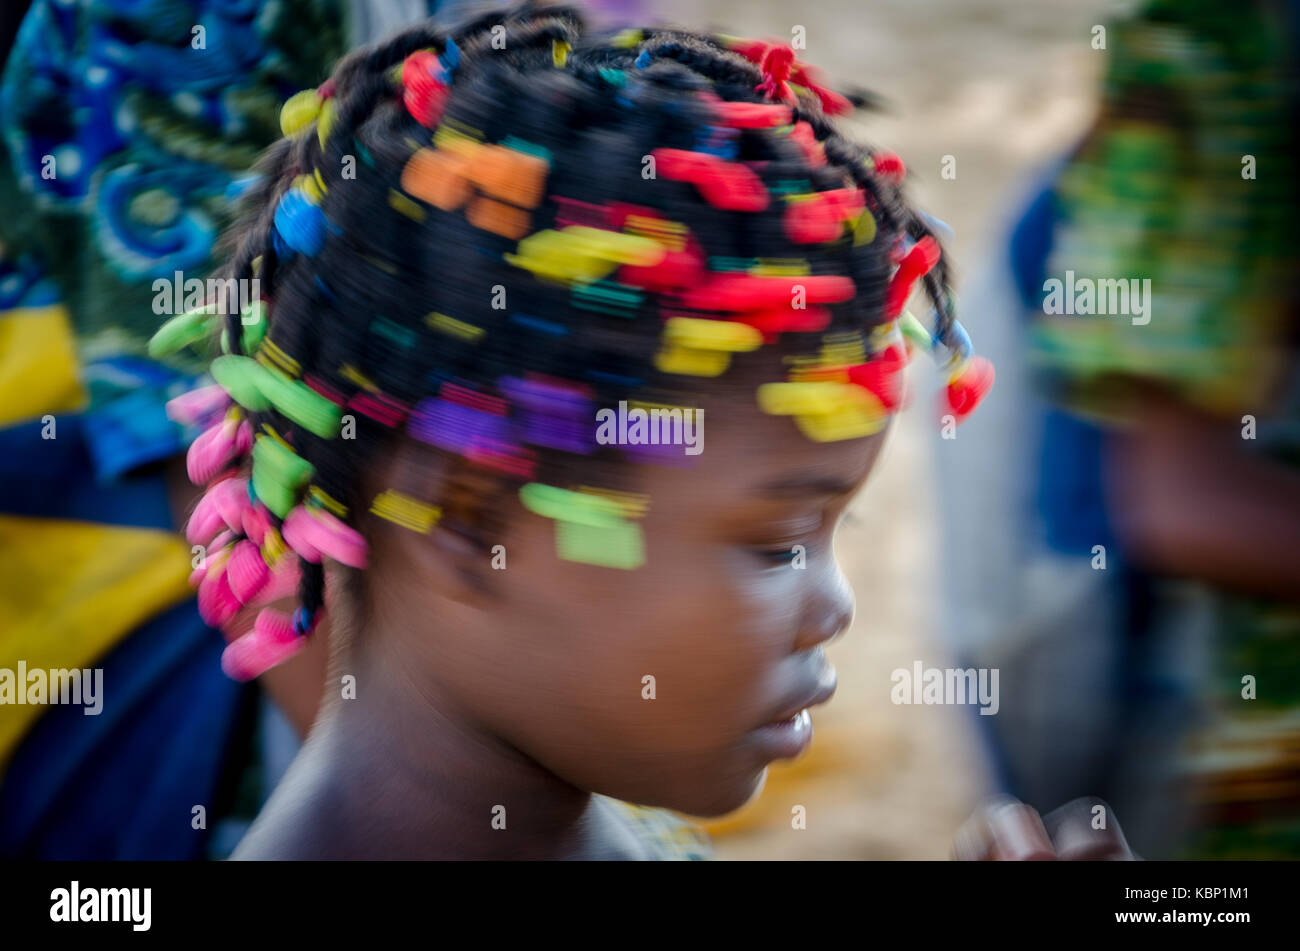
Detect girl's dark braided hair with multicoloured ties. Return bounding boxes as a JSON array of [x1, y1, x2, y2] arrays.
[[152, 3, 991, 676]]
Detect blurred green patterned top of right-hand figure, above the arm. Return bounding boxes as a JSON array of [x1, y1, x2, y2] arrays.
[[1031, 0, 1297, 414]]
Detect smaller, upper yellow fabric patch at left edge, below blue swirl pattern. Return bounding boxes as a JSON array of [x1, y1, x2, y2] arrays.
[[0, 304, 86, 426]]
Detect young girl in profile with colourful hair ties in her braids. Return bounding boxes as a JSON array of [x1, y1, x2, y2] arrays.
[[155, 4, 992, 859]]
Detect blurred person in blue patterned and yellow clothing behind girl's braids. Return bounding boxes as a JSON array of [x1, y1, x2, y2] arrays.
[[0, 0, 473, 859]]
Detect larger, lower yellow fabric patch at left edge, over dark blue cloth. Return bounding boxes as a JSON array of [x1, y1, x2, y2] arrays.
[[0, 514, 192, 772]]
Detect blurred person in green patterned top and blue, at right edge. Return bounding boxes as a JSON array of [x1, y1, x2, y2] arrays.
[[940, 0, 1300, 857]]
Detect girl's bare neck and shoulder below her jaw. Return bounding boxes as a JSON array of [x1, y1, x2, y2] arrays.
[[235, 641, 644, 859]]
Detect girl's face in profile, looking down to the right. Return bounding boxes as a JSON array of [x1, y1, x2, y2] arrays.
[[368, 387, 883, 816]]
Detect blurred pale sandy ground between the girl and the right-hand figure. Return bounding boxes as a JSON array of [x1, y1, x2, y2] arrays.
[[651, 0, 1106, 859]]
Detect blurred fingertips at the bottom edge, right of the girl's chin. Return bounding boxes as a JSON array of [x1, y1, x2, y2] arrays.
[[953, 796, 1138, 861]]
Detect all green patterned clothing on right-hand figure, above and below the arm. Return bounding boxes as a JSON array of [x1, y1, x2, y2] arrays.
[[1031, 0, 1300, 859]]
